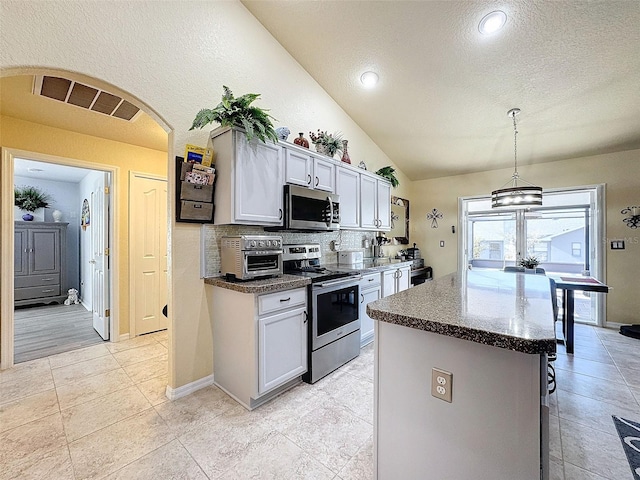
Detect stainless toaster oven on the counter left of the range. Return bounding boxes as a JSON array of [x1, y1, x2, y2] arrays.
[[220, 235, 282, 280]]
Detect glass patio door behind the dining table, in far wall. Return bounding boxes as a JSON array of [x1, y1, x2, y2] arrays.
[[461, 187, 604, 325]]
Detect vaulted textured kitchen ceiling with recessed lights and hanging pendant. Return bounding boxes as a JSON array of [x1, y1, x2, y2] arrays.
[[242, 0, 640, 180]]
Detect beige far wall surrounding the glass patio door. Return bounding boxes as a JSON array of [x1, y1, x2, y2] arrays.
[[410, 150, 640, 323]]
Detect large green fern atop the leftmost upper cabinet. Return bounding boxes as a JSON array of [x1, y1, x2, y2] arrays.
[[189, 86, 278, 142]]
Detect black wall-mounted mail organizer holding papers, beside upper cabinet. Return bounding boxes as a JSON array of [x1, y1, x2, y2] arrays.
[[176, 157, 215, 223]]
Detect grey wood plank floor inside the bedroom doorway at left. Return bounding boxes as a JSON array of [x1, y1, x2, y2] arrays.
[[14, 305, 104, 363]]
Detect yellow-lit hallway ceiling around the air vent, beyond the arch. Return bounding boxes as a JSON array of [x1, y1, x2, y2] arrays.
[[0, 75, 168, 151]]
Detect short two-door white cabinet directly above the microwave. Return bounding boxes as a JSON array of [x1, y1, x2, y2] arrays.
[[285, 145, 336, 193]]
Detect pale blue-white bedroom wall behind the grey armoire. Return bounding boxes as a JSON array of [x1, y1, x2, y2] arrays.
[[13, 175, 80, 292]]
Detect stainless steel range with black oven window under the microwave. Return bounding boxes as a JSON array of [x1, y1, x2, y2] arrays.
[[282, 244, 361, 383]]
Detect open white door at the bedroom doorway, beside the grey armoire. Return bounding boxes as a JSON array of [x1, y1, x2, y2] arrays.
[[88, 172, 111, 340]]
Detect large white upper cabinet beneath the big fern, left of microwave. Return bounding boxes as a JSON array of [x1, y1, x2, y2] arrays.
[[211, 127, 284, 225]]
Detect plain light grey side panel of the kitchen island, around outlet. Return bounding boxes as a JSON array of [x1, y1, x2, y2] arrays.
[[374, 321, 540, 480]]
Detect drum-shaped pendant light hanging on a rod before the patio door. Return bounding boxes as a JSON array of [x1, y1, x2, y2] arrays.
[[491, 108, 542, 208]]
